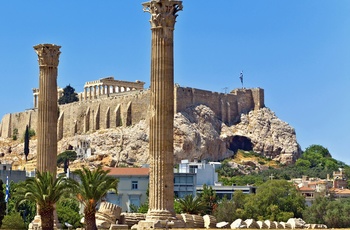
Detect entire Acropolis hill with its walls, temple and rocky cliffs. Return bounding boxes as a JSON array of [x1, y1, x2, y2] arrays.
[[0, 77, 301, 164]]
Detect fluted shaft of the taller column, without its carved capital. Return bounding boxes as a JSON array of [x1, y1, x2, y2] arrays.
[[149, 28, 174, 217]]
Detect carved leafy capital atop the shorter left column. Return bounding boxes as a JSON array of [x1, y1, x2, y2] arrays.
[[34, 44, 61, 67]]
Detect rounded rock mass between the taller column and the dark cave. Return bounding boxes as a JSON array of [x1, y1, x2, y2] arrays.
[[174, 105, 234, 161]]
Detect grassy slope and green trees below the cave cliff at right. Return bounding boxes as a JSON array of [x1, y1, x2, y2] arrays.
[[218, 145, 350, 185]]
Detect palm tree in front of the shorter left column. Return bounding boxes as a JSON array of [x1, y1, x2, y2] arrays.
[[16, 172, 71, 230]]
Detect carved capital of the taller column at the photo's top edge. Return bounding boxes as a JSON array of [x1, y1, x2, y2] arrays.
[[142, 0, 182, 30]]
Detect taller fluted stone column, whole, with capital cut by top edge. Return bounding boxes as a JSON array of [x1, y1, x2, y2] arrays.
[[143, 0, 182, 221]]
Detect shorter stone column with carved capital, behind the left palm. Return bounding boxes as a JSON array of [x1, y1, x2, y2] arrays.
[[34, 44, 61, 175]]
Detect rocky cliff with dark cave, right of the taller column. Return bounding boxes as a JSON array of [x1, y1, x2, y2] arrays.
[[174, 105, 301, 164]]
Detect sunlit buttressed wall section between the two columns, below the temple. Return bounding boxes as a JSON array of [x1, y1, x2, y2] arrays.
[[58, 90, 150, 139]]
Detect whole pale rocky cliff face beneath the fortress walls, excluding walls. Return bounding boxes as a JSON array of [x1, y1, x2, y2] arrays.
[[0, 105, 301, 167]]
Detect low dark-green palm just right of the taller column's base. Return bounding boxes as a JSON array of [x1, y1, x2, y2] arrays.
[[177, 194, 206, 215]]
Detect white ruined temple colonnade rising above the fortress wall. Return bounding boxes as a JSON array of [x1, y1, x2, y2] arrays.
[[79, 77, 145, 101]]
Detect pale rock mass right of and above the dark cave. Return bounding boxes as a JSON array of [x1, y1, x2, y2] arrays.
[[227, 108, 301, 164]]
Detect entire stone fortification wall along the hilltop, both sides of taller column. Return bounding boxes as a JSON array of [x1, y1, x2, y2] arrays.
[[0, 87, 264, 140]]
